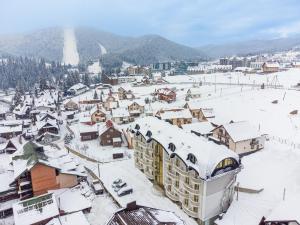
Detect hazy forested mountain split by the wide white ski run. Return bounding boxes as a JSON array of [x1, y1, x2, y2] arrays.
[[0, 28, 204, 65]]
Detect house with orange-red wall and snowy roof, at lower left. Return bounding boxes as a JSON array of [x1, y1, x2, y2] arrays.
[[11, 142, 86, 199]]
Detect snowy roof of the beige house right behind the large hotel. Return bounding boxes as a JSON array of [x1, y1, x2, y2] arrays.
[[219, 121, 261, 142]]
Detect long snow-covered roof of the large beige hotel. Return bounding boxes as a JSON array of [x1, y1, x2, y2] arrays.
[[131, 117, 239, 179]]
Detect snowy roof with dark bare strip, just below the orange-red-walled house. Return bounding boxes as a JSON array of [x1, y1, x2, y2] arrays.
[[13, 194, 59, 225]]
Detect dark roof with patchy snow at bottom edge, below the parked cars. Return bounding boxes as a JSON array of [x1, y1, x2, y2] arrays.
[[106, 202, 185, 225]]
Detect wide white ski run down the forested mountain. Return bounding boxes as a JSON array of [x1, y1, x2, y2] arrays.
[[63, 28, 79, 66]]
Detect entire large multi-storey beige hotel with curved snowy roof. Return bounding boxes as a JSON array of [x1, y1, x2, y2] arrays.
[[129, 117, 241, 225]]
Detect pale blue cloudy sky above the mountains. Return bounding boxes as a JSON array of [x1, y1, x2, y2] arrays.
[[0, 0, 300, 47]]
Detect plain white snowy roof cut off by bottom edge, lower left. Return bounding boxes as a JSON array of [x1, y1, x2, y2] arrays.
[[46, 212, 90, 225]]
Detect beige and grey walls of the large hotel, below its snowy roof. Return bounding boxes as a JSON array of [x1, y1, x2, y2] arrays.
[[133, 122, 237, 225]]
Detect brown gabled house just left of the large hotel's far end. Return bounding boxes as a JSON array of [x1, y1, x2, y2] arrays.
[[99, 120, 123, 147]]
